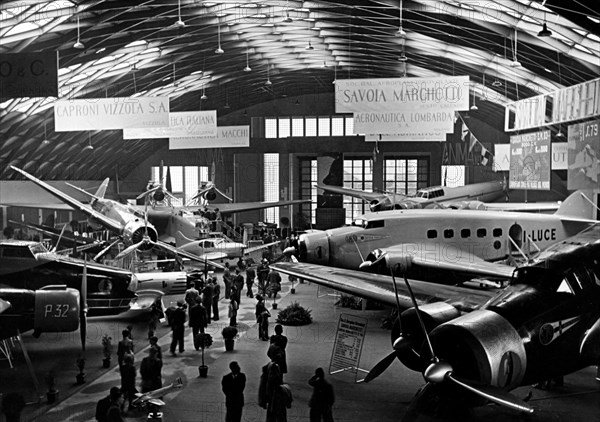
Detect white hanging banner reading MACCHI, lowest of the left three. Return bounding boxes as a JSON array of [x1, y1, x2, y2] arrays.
[[169, 126, 250, 149]]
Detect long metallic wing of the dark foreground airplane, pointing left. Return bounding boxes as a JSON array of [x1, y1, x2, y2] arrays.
[[271, 262, 496, 312]]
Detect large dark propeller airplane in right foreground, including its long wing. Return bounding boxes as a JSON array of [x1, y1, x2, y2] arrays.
[[272, 223, 600, 417]]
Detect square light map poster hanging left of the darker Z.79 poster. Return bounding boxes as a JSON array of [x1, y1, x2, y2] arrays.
[[509, 130, 550, 190]]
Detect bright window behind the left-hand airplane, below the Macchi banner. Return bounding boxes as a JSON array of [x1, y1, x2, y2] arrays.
[[150, 166, 208, 206]]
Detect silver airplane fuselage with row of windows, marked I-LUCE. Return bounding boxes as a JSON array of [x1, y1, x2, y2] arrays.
[[300, 209, 589, 269]]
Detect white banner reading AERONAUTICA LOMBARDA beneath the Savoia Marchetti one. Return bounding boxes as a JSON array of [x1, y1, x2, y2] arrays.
[[354, 110, 454, 139]]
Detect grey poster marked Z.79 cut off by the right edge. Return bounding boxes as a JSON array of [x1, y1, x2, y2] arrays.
[[567, 120, 600, 190]]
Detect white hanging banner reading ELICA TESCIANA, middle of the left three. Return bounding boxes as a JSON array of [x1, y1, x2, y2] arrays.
[[123, 110, 217, 139]]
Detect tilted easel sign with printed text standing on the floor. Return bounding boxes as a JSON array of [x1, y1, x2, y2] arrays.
[[329, 314, 369, 382]]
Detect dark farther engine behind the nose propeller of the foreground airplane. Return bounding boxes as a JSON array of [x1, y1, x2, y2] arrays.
[[392, 302, 460, 371]]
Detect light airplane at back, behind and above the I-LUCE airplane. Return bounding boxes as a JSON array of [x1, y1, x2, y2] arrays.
[[315, 181, 506, 212]]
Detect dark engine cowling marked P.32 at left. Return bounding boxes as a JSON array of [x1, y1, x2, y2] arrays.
[[33, 286, 80, 333]]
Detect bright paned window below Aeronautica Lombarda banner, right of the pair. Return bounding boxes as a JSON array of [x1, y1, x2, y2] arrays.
[[383, 158, 429, 195]]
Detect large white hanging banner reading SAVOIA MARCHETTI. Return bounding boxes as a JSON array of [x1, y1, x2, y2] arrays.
[[335, 76, 469, 112]]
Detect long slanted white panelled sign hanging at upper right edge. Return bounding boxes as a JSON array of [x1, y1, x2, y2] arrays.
[[504, 78, 600, 132]]
